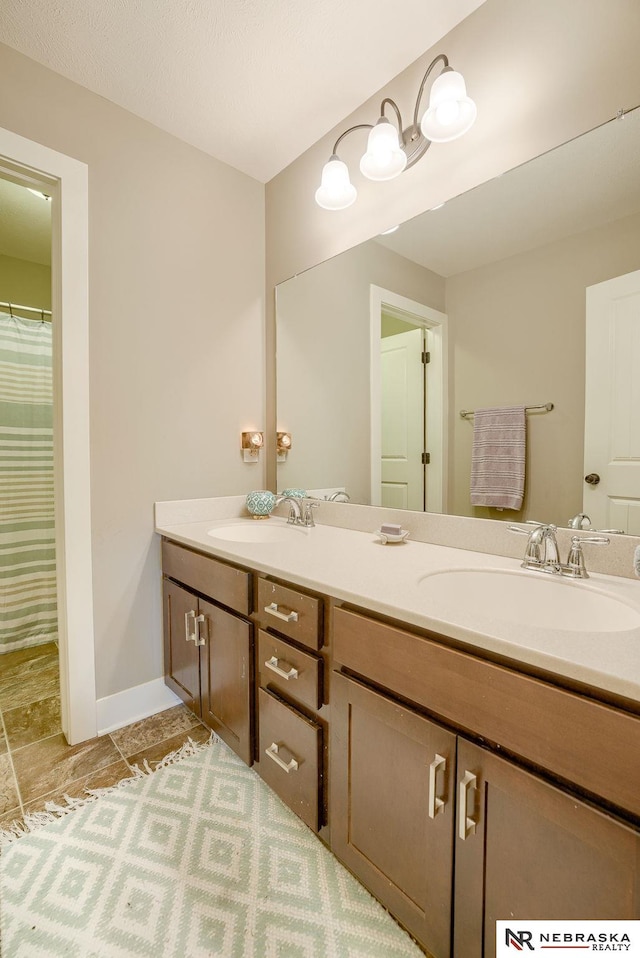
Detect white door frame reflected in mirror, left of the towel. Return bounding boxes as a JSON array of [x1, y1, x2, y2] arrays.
[[369, 283, 449, 513]]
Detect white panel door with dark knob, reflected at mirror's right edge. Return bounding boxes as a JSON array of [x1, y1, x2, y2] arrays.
[[583, 270, 640, 535]]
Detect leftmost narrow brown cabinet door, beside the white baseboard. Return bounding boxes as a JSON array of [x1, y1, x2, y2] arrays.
[[163, 579, 202, 716]]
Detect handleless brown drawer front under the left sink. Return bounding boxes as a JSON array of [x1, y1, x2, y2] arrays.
[[162, 539, 251, 615]]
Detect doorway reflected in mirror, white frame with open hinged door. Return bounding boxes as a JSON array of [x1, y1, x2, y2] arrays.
[[370, 285, 447, 512]]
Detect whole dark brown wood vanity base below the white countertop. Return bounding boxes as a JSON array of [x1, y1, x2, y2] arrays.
[[163, 540, 640, 958]]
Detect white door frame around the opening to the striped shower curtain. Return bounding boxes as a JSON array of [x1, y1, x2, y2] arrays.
[[0, 127, 97, 745]]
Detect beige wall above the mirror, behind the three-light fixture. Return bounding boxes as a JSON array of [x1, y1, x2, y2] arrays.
[[266, 0, 640, 488]]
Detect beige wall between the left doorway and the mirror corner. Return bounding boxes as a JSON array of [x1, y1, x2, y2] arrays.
[[0, 46, 264, 697]]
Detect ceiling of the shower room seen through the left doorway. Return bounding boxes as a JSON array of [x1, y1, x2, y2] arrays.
[[0, 179, 51, 264]]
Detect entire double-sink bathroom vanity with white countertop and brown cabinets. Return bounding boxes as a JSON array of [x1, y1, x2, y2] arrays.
[[156, 506, 640, 958]]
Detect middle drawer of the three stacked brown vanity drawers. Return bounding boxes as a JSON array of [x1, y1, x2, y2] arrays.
[[258, 629, 322, 710]]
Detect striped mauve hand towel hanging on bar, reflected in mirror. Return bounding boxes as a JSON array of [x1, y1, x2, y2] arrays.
[[471, 406, 526, 509]]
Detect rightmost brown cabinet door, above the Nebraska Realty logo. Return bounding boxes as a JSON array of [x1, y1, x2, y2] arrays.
[[454, 739, 640, 958]]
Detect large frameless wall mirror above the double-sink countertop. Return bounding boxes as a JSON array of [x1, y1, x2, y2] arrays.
[[276, 109, 640, 535]]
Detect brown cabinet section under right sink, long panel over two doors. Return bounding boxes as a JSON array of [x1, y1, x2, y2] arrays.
[[330, 609, 640, 958]]
